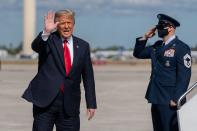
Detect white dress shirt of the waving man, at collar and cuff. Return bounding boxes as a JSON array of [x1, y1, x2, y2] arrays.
[[41, 30, 74, 65]]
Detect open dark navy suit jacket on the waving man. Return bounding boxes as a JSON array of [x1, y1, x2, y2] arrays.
[[22, 32, 96, 115]]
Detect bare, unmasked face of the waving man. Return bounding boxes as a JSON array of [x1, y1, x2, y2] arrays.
[[57, 15, 74, 39]]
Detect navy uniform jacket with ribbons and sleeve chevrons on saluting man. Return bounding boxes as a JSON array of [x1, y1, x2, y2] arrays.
[[133, 38, 191, 105]]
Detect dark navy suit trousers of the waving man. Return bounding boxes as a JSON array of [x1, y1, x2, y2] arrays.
[[33, 91, 80, 131]]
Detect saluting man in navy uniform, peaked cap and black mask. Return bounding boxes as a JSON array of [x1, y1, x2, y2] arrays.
[[133, 14, 191, 131]]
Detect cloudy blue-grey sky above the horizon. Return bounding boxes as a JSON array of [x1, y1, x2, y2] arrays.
[[0, 0, 197, 48]]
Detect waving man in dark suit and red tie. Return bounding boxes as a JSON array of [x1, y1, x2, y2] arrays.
[[23, 10, 97, 131]]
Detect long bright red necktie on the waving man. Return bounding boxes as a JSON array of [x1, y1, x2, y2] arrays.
[[64, 40, 71, 76]]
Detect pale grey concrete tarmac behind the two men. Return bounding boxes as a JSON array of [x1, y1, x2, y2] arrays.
[[0, 64, 197, 131]]
